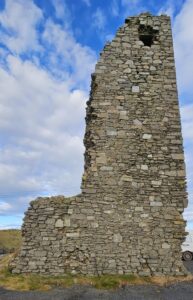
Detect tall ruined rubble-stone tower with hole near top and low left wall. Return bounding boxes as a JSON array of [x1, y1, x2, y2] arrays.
[[12, 13, 187, 275]]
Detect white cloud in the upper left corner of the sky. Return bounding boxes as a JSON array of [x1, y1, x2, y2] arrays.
[[0, 0, 43, 53]]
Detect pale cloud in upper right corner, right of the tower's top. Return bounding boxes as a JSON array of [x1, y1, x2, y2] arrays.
[[173, 0, 193, 95]]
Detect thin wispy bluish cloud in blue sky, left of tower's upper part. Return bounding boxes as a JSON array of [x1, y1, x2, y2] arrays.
[[43, 20, 96, 88]]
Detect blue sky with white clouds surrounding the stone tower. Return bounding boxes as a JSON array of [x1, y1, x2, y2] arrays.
[[0, 0, 193, 228]]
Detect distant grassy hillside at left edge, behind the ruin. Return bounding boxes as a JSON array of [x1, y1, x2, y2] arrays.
[[0, 229, 21, 252]]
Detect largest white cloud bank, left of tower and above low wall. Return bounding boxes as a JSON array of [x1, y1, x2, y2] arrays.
[[0, 56, 87, 204]]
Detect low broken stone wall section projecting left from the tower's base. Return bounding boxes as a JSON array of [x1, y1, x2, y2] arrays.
[[12, 196, 94, 274]]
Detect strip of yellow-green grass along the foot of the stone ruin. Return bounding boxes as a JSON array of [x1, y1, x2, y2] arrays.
[[0, 254, 193, 291]]
